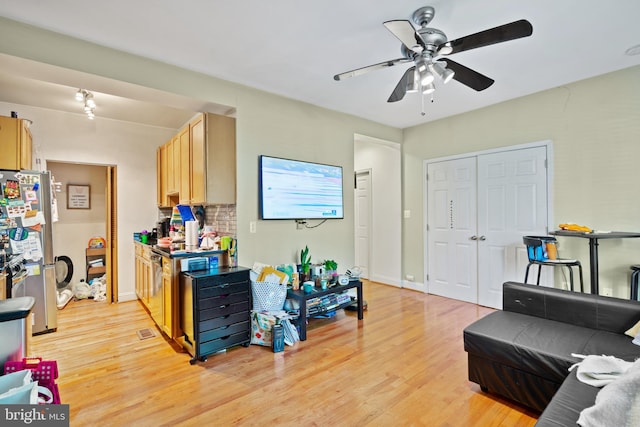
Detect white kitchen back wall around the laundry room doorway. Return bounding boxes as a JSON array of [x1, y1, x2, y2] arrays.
[[0, 102, 176, 301]]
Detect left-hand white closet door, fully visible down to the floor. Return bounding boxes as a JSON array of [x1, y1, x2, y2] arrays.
[[426, 157, 478, 302]]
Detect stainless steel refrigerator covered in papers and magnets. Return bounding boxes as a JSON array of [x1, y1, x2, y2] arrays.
[[0, 170, 58, 334]]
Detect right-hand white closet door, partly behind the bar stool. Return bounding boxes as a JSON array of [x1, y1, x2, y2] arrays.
[[478, 147, 547, 308]]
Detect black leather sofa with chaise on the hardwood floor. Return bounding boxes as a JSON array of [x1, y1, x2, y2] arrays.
[[464, 282, 640, 427]]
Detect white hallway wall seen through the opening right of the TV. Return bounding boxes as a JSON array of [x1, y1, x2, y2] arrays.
[[350, 135, 402, 286]]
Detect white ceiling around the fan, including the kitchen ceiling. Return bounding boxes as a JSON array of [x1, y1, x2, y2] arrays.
[[0, 0, 640, 128]]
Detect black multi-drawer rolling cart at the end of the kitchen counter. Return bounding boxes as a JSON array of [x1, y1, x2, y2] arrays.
[[180, 267, 252, 365]]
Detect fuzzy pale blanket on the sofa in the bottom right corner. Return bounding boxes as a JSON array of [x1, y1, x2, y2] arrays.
[[578, 359, 640, 427]]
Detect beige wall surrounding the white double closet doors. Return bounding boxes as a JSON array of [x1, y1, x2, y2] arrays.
[[403, 67, 640, 297]]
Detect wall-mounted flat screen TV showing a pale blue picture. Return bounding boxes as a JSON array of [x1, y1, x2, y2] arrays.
[[258, 156, 344, 219]]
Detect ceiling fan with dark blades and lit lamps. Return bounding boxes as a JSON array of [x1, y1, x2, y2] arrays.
[[333, 6, 533, 106]]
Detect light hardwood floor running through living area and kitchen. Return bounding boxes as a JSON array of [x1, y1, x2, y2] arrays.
[[32, 282, 537, 426]]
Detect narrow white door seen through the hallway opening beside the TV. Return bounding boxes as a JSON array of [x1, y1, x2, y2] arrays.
[[354, 171, 371, 279]]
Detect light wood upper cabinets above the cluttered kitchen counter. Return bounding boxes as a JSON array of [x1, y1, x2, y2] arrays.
[[158, 113, 236, 206]]
